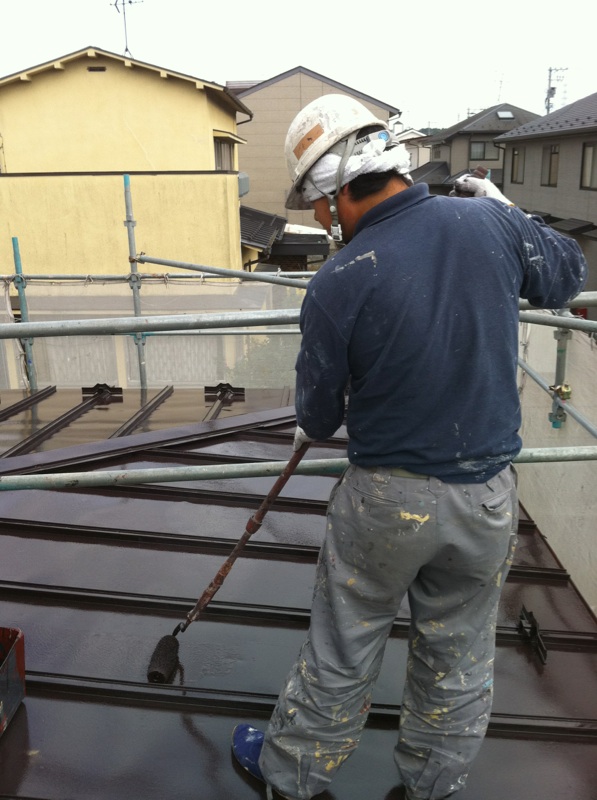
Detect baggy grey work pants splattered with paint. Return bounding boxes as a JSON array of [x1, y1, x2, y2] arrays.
[[259, 465, 518, 800]]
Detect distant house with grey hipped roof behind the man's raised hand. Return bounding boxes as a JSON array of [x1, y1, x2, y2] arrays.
[[412, 103, 538, 194]]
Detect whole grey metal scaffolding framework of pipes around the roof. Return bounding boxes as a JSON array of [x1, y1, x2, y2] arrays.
[[0, 175, 597, 476]]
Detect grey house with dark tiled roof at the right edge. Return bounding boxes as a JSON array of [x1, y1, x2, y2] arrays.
[[496, 92, 597, 310]]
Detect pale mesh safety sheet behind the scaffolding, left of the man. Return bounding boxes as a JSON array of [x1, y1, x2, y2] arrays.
[[0, 276, 304, 388]]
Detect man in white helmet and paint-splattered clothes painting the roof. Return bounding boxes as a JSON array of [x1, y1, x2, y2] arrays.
[[232, 95, 586, 800]]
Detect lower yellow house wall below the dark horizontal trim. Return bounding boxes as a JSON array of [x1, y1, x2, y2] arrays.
[[0, 173, 242, 275]]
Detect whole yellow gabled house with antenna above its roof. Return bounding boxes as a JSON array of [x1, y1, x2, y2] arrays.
[[0, 47, 250, 274]]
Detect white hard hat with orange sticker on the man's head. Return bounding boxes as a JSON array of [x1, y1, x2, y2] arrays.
[[285, 94, 389, 209]]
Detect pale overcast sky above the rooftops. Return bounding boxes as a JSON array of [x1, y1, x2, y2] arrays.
[[0, 0, 597, 128]]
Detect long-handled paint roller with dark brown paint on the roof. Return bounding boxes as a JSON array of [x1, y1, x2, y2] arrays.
[[147, 442, 310, 683]]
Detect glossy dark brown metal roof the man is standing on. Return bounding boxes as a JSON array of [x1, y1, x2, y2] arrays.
[[0, 389, 597, 800]]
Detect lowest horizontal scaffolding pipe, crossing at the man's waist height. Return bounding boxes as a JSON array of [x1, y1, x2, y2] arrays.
[[0, 446, 597, 491]]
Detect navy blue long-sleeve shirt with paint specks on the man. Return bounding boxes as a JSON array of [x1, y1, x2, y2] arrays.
[[296, 185, 586, 483]]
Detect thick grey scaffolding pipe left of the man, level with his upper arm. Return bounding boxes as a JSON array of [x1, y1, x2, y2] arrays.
[[0, 308, 300, 339]]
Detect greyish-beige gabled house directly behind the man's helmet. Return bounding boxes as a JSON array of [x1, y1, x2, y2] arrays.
[[226, 67, 400, 226]]
